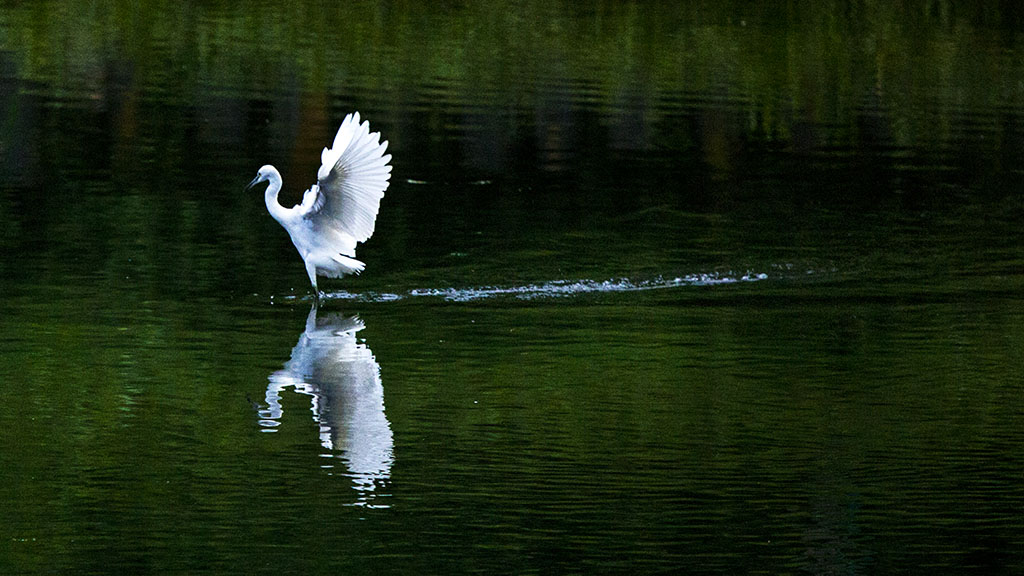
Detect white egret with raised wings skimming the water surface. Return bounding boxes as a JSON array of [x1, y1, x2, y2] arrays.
[[246, 112, 391, 300]]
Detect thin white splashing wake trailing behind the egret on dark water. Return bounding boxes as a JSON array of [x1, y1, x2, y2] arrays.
[[276, 272, 768, 302]]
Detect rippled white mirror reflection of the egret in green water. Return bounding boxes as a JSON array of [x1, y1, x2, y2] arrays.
[[260, 305, 394, 503]]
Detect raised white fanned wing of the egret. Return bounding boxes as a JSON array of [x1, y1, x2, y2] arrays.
[[301, 112, 391, 256]]
